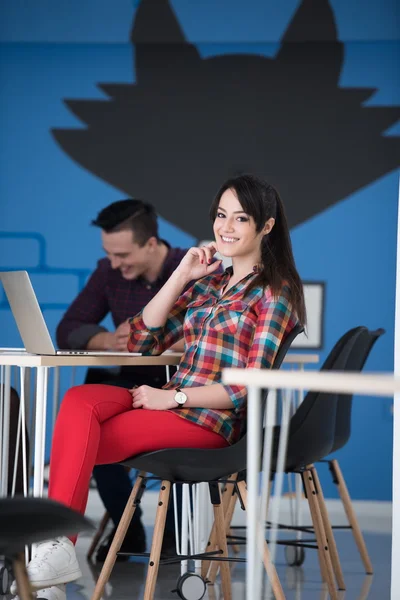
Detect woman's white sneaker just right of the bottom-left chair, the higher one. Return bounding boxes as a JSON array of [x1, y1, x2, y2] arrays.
[[11, 536, 82, 600]]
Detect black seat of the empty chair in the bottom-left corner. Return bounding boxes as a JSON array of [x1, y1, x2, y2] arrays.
[[0, 496, 94, 556]]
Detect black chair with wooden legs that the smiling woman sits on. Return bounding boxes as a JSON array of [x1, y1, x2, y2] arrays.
[[92, 326, 303, 600]]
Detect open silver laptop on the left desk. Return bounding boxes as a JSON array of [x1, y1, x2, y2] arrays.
[[0, 271, 141, 356]]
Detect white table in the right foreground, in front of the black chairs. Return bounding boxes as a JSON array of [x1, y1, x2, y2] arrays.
[[222, 369, 400, 600]]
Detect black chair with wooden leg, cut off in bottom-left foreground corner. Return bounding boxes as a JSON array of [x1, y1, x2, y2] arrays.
[[0, 496, 93, 600]]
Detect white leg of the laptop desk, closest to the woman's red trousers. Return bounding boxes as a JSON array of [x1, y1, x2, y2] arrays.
[[33, 367, 49, 497]]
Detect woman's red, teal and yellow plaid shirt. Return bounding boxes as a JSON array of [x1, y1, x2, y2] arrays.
[[128, 267, 297, 444]]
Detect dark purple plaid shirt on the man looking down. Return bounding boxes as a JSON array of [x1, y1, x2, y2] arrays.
[[57, 242, 187, 350]]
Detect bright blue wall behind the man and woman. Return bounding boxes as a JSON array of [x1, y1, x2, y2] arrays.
[[0, 0, 400, 500]]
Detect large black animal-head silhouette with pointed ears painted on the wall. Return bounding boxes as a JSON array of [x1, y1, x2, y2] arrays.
[[52, 0, 400, 239]]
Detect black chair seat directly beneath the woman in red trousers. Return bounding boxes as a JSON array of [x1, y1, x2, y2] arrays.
[[121, 440, 246, 483]]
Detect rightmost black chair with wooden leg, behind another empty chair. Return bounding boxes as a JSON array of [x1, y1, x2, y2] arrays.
[[320, 327, 385, 574]]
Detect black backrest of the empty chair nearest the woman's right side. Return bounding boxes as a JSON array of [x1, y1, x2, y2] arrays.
[[286, 327, 365, 469]]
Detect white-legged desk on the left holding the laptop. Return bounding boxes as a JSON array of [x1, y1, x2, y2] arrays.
[[0, 350, 182, 496]]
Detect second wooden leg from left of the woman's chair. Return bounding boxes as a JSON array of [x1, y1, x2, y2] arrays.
[[143, 480, 171, 600]]
